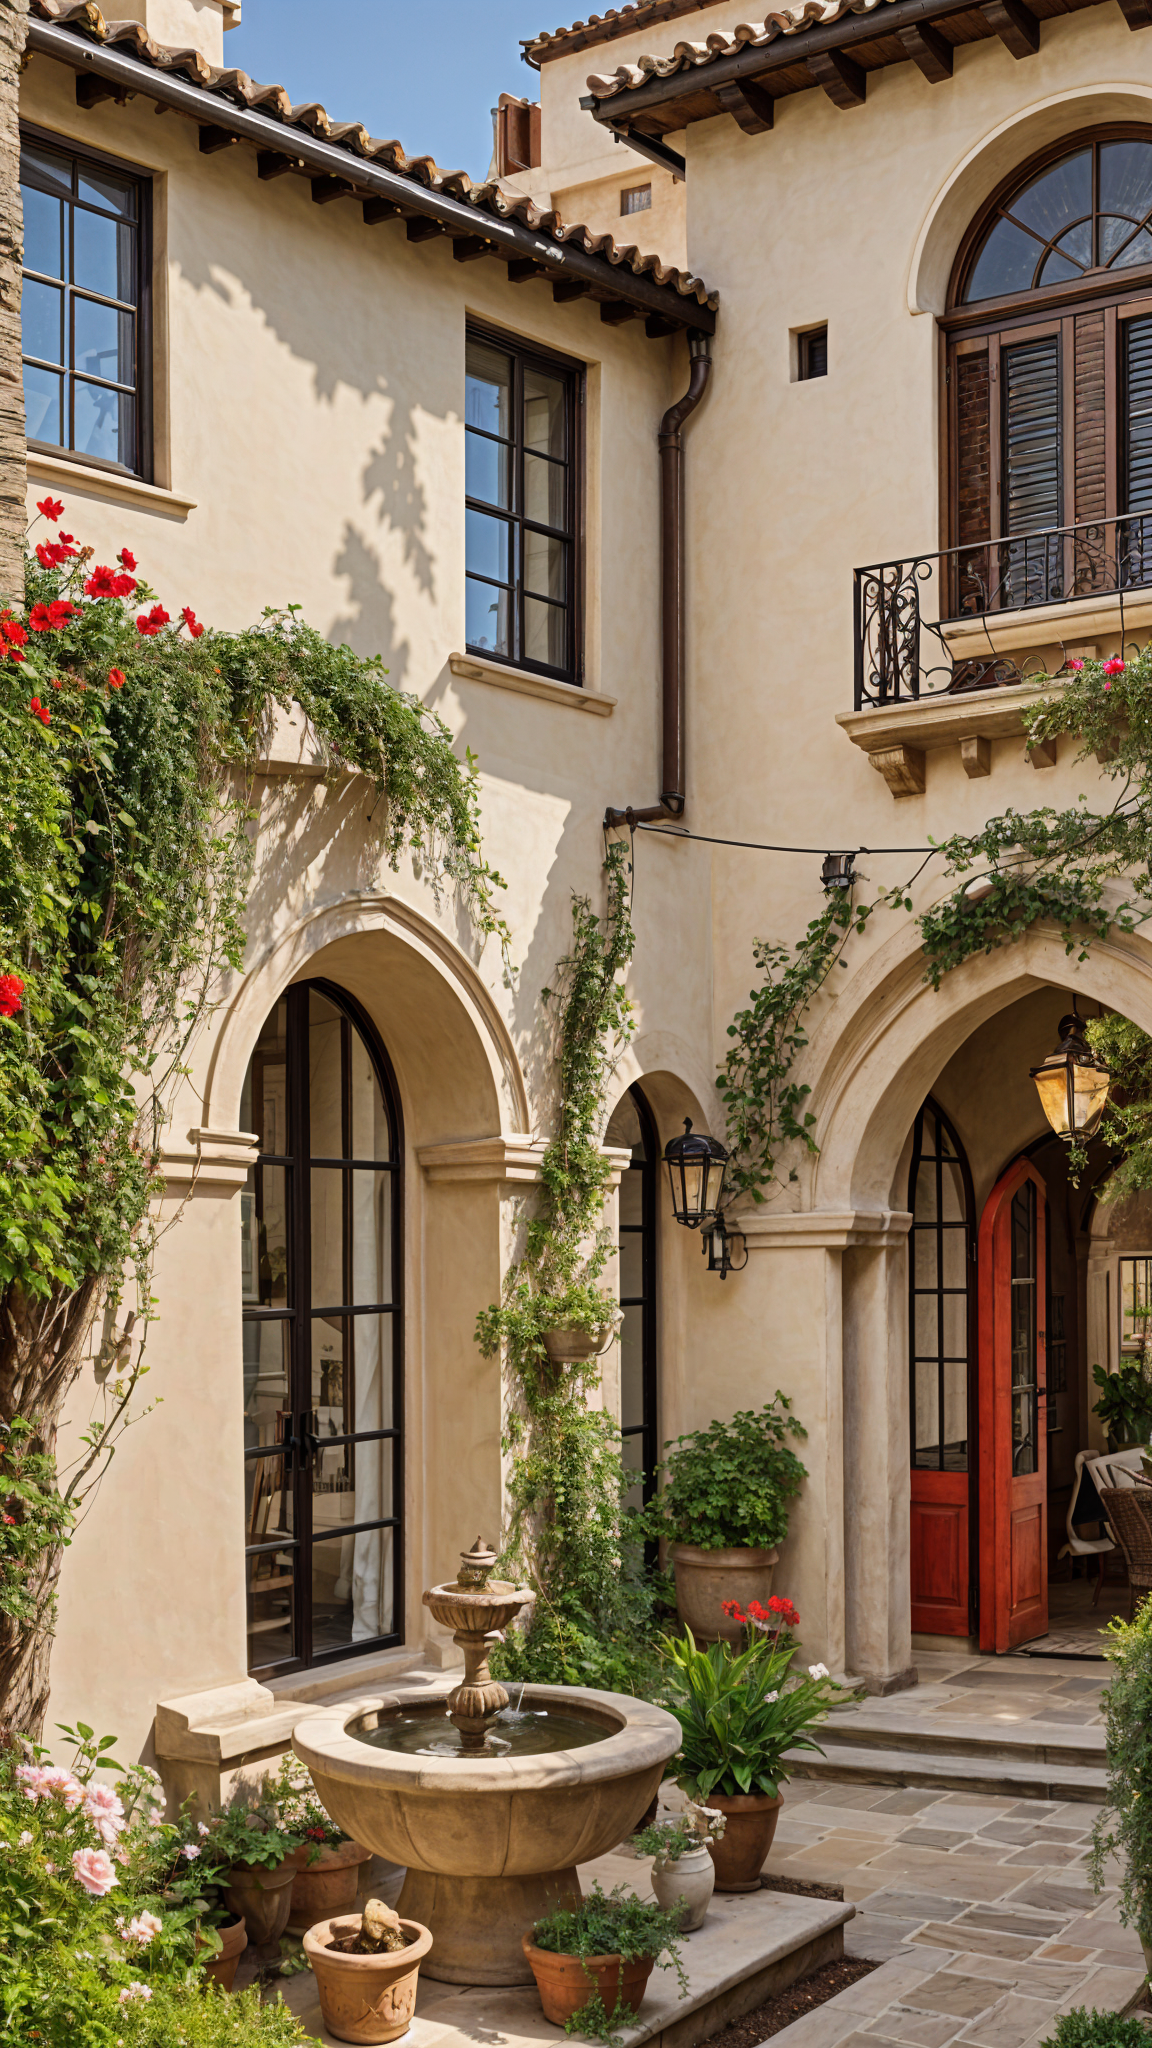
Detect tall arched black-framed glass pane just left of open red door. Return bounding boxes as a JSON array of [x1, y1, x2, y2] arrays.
[[908, 1098, 976, 1473]]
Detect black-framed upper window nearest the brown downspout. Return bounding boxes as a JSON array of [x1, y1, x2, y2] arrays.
[[465, 330, 580, 682]]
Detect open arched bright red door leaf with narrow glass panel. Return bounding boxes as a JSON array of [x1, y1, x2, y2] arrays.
[[978, 1159, 1047, 1651]]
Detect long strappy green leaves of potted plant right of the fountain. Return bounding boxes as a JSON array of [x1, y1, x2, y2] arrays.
[[664, 1628, 855, 1802]]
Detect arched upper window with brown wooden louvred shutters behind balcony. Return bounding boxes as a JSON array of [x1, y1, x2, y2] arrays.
[[943, 127, 1152, 612]]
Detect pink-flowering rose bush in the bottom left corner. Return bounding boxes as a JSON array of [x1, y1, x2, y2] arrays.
[[0, 1724, 307, 2048]]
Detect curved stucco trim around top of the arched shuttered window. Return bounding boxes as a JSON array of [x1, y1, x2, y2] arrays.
[[908, 80, 1152, 313]]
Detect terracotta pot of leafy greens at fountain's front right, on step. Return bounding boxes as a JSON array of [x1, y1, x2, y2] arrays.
[[523, 1884, 689, 2042]]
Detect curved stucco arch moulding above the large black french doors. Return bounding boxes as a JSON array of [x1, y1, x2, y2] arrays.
[[194, 891, 531, 1137]]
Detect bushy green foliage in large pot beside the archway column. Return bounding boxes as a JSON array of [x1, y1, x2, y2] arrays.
[[640, 1389, 808, 1550]]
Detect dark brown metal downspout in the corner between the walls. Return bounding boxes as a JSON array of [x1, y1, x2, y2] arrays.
[[605, 334, 711, 827]]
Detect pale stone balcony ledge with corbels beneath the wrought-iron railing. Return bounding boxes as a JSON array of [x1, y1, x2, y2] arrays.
[[836, 680, 1060, 797]]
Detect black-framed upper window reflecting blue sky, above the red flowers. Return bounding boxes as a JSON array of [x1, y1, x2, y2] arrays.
[[20, 129, 152, 475]]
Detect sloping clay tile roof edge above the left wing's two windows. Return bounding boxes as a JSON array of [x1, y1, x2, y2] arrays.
[[31, 0, 719, 311]]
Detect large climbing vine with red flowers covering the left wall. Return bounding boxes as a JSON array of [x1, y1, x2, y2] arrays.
[[0, 498, 508, 1735]]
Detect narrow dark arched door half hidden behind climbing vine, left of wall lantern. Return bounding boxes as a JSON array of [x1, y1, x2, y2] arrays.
[[605, 1087, 660, 1507]]
